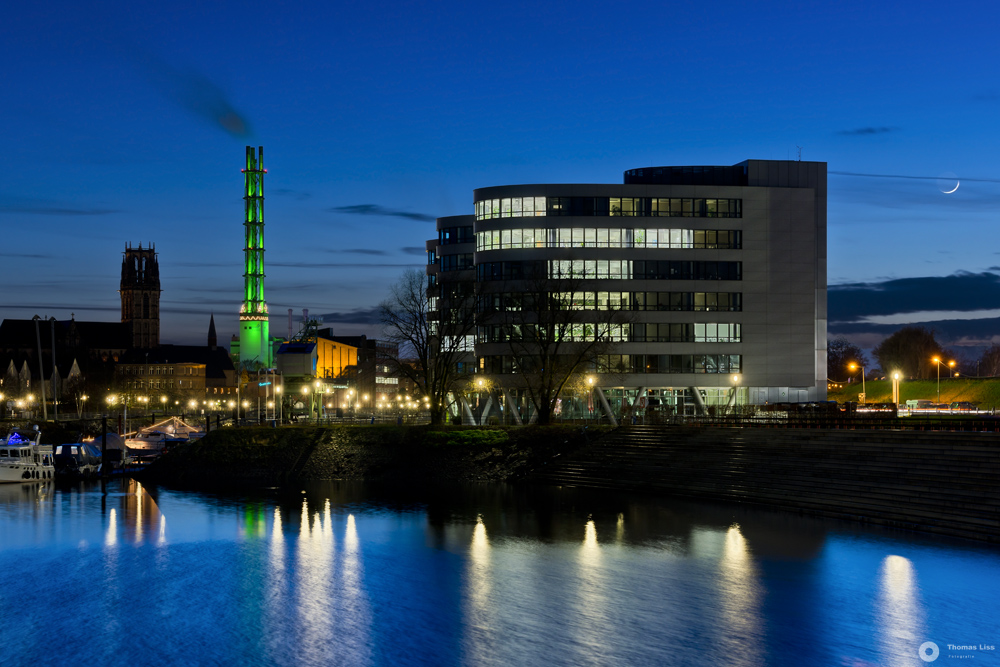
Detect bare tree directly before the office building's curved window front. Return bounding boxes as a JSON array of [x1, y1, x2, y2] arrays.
[[483, 268, 628, 424]]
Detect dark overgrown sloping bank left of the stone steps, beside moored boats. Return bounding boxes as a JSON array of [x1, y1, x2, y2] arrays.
[[142, 426, 609, 487]]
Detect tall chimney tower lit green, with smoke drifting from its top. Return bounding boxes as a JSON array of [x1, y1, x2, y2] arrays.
[[239, 146, 271, 368]]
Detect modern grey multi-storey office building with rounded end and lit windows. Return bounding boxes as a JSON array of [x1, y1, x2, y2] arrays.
[[427, 160, 827, 414]]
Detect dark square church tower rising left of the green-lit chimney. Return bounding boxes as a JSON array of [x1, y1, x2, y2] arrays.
[[118, 243, 160, 349]]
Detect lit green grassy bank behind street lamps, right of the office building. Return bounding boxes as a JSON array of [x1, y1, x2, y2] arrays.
[[827, 377, 1000, 410]]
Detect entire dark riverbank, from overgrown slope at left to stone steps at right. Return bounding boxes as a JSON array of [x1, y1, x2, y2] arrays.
[[142, 426, 1000, 543]]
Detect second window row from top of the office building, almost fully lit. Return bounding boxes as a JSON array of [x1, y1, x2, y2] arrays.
[[476, 227, 743, 250]]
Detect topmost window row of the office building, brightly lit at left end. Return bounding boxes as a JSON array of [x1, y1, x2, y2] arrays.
[[475, 197, 743, 220]]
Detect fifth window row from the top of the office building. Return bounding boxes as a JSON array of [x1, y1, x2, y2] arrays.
[[477, 322, 742, 343]]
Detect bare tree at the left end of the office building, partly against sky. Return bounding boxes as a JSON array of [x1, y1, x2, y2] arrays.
[[379, 270, 476, 424]]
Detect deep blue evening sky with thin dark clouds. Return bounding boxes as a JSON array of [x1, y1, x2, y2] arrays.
[[0, 1, 1000, 350]]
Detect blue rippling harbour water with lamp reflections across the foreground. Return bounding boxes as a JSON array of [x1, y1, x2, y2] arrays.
[[0, 482, 1000, 667]]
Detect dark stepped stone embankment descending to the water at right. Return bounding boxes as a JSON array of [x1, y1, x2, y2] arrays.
[[528, 426, 1000, 542]]
